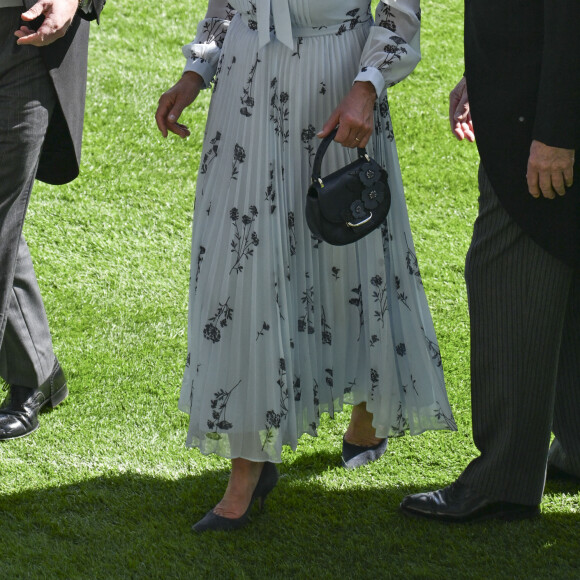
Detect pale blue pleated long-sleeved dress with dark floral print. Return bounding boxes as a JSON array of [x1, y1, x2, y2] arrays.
[[179, 0, 456, 462]]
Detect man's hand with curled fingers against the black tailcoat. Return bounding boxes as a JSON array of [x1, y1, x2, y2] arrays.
[[526, 141, 574, 199]]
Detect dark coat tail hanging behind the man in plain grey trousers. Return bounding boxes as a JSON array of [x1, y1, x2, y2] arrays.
[[24, 0, 106, 184]]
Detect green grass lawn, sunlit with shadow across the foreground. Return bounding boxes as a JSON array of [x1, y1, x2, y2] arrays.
[[0, 0, 580, 579]]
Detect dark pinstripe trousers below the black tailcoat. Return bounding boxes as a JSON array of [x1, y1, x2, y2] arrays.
[[459, 167, 580, 505]]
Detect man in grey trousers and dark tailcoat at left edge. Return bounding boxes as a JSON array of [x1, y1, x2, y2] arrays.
[[0, 0, 105, 439]]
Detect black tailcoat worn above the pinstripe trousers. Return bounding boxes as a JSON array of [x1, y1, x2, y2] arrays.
[[465, 0, 580, 268]]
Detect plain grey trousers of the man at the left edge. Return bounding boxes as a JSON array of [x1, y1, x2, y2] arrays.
[[0, 8, 56, 387]]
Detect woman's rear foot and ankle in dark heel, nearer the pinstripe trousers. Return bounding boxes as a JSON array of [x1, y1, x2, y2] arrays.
[[342, 403, 388, 469]]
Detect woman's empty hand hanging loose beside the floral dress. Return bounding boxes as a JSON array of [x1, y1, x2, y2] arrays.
[[155, 71, 204, 139]]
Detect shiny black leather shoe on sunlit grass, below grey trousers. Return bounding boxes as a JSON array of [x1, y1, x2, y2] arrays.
[[0, 360, 68, 440]]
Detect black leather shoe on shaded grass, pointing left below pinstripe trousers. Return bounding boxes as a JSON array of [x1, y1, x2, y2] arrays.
[[400, 482, 540, 523]]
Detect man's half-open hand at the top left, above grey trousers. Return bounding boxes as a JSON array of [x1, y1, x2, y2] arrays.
[[14, 0, 79, 46]]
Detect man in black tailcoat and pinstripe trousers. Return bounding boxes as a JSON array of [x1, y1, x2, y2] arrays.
[[401, 0, 580, 522]]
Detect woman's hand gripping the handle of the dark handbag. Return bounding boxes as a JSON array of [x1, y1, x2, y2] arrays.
[[316, 81, 377, 147]]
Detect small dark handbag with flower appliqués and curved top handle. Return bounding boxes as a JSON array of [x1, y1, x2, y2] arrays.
[[305, 128, 391, 246]]
